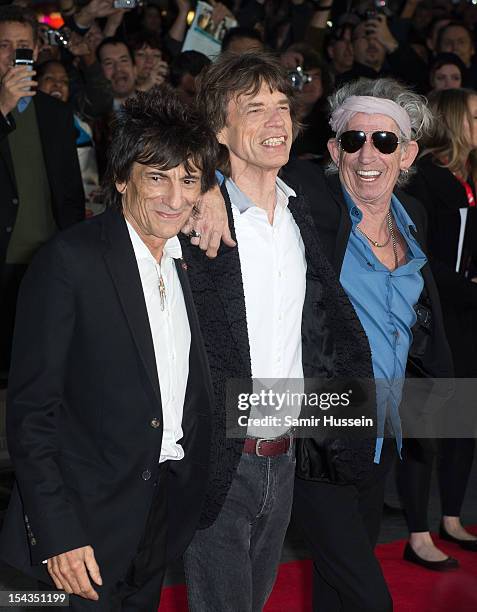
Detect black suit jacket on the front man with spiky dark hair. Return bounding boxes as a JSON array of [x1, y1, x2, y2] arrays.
[[0, 210, 212, 584]]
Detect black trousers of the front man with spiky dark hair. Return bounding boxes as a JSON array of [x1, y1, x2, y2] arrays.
[[42, 461, 168, 612]]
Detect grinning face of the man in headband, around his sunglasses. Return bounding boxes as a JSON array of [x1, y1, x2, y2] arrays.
[[328, 113, 418, 205]]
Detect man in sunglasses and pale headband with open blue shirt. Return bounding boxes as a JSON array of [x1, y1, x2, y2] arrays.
[[284, 79, 452, 612]]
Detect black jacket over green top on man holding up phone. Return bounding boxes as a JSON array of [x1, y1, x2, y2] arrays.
[[0, 92, 84, 263]]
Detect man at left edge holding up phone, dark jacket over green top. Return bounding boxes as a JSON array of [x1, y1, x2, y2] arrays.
[[0, 5, 84, 371]]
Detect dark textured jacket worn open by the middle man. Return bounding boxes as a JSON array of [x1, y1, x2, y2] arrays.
[[181, 180, 372, 527]]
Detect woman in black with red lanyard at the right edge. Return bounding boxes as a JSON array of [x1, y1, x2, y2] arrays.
[[398, 89, 477, 571]]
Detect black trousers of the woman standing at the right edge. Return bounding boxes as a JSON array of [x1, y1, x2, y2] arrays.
[[397, 438, 475, 533]]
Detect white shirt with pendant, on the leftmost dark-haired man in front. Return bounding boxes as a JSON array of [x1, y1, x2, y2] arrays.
[[127, 223, 191, 463]]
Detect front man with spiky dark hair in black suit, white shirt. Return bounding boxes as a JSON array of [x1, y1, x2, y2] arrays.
[[0, 89, 218, 612]]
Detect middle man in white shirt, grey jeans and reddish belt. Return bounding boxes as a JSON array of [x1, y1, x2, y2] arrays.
[[183, 54, 307, 612]]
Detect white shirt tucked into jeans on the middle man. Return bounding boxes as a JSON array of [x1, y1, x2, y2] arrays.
[[226, 178, 306, 438]]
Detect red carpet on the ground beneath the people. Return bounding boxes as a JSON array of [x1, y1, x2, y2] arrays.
[[159, 527, 477, 612]]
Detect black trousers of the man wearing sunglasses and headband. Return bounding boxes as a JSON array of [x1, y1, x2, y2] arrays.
[[293, 440, 395, 612]]
